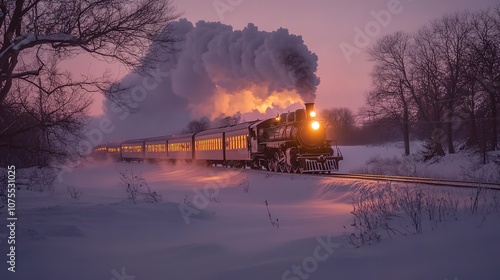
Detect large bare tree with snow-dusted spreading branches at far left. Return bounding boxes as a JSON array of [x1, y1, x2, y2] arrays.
[[0, 0, 179, 164]]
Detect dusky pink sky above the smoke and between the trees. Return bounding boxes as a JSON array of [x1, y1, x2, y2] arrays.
[[81, 0, 498, 115]]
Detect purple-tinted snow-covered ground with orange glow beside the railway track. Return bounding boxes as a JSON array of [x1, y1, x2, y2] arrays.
[[0, 143, 500, 280]]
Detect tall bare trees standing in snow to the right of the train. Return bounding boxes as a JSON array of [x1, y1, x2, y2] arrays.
[[362, 5, 500, 159]]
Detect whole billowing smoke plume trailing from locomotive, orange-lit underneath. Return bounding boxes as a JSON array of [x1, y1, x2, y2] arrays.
[[104, 19, 320, 141]]
